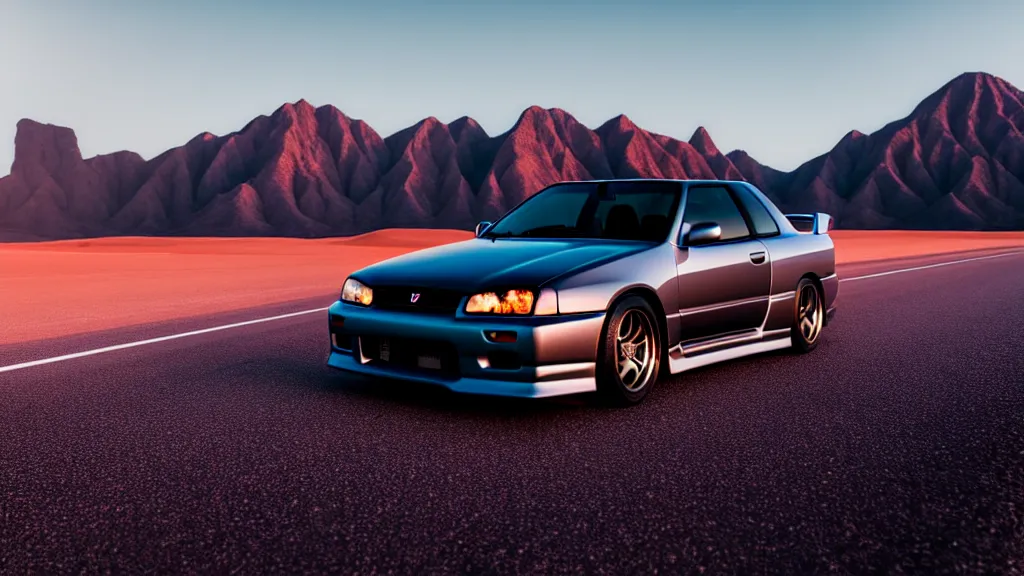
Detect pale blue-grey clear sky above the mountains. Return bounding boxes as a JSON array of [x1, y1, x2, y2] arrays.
[[0, 0, 1024, 174]]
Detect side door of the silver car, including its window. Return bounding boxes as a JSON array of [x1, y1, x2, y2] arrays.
[[676, 183, 771, 342]]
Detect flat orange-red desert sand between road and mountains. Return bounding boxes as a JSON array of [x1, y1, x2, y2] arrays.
[[0, 230, 1024, 344]]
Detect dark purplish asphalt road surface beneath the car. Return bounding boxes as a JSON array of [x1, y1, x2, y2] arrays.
[[0, 249, 1024, 574]]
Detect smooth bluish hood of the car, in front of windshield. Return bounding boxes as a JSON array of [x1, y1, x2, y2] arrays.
[[352, 238, 652, 293]]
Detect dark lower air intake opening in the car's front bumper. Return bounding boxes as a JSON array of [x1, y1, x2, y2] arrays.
[[359, 336, 459, 378]]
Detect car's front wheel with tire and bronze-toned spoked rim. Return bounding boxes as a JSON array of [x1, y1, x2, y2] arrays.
[[595, 296, 662, 406]]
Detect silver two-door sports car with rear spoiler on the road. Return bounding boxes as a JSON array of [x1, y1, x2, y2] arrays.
[[328, 179, 839, 404]]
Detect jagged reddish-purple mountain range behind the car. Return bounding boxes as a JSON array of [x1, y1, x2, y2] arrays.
[[0, 73, 1024, 241]]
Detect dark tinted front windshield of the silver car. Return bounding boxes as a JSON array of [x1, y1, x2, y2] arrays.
[[483, 180, 682, 242]]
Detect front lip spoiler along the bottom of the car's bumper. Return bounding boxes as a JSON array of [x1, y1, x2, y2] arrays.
[[327, 351, 597, 398]]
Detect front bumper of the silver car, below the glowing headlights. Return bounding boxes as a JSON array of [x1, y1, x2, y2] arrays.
[[328, 301, 604, 398]]
